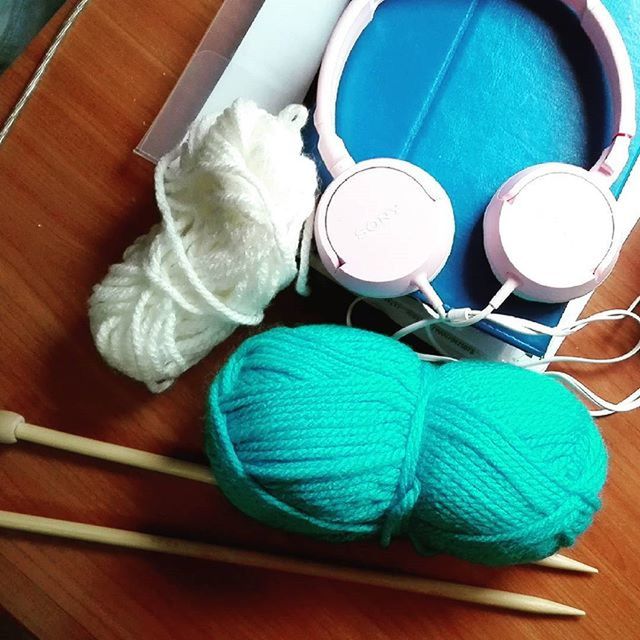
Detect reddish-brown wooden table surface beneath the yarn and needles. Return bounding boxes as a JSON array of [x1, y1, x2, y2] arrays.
[[0, 0, 640, 640]]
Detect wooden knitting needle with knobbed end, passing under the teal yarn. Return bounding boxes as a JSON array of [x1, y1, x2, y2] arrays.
[[0, 411, 598, 573]]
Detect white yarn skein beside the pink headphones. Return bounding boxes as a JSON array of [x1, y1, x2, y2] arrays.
[[89, 101, 317, 393]]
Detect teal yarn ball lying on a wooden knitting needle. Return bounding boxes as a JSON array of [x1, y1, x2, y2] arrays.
[[206, 326, 607, 565]]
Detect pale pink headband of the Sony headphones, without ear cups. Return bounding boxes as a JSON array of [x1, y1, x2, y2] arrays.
[[315, 0, 636, 182]]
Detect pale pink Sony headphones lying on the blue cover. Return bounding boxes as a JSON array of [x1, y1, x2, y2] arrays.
[[315, 0, 636, 303]]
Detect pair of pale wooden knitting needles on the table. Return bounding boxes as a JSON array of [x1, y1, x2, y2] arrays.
[[0, 411, 598, 616]]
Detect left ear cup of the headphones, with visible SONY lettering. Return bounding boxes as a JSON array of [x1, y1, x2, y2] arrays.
[[315, 159, 455, 298]]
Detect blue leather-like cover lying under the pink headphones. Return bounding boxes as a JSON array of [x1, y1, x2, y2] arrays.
[[308, 0, 640, 355]]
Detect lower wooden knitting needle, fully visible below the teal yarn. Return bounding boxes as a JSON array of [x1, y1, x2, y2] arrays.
[[0, 511, 586, 616]]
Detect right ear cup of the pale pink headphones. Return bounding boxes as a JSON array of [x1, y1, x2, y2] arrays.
[[484, 163, 619, 303]]
